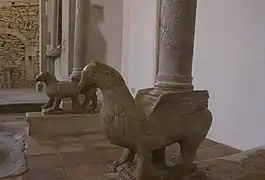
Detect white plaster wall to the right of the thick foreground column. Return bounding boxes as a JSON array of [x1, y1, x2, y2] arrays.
[[193, 0, 265, 149]]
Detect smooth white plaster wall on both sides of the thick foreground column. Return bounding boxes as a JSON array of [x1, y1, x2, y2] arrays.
[[122, 0, 265, 149]]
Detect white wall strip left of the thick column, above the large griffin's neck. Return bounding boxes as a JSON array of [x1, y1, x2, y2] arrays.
[[122, 0, 157, 94]]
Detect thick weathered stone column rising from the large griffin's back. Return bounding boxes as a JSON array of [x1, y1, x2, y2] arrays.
[[155, 0, 197, 90]]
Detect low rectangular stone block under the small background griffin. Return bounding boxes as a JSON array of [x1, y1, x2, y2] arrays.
[[26, 112, 100, 139]]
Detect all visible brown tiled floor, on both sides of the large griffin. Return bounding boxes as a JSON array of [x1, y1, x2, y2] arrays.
[[0, 114, 239, 180]]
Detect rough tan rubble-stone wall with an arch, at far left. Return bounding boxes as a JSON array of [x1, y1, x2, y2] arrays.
[[0, 0, 39, 88]]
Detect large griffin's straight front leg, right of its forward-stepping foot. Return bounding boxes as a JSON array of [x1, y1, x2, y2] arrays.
[[135, 150, 152, 180]]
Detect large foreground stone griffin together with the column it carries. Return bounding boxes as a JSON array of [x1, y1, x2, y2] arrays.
[[79, 0, 212, 180]]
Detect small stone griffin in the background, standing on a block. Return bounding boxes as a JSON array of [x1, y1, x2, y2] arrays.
[[35, 72, 97, 113]]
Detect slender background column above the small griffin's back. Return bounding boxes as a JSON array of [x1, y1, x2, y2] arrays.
[[71, 0, 90, 77]]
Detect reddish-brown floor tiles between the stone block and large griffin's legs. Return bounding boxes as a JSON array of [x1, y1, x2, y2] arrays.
[[23, 134, 122, 180]]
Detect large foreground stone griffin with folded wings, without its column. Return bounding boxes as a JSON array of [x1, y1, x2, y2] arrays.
[[78, 61, 212, 180]]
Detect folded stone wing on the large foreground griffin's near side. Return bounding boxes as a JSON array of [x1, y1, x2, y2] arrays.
[[149, 91, 209, 118]]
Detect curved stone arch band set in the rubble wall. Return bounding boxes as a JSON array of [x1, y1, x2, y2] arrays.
[[0, 26, 33, 57]]
